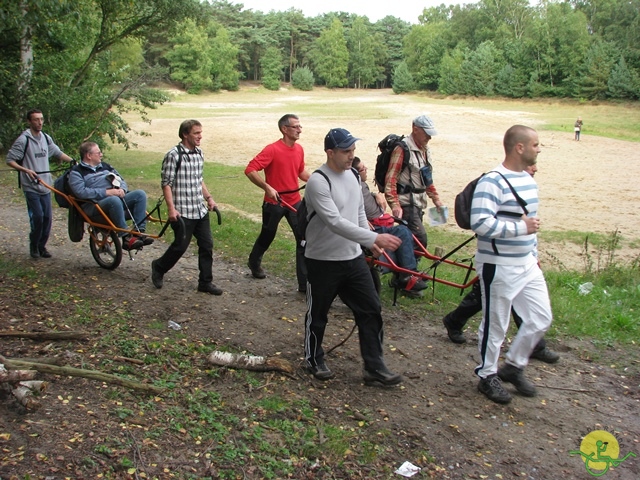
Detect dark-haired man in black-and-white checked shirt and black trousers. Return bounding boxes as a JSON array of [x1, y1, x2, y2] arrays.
[[151, 120, 222, 295]]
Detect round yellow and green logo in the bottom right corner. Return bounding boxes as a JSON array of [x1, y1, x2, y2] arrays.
[[569, 430, 636, 477]]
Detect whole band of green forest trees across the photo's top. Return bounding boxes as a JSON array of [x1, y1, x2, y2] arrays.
[[0, 0, 640, 149]]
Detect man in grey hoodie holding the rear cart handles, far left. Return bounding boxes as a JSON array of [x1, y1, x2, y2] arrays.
[[7, 109, 73, 258]]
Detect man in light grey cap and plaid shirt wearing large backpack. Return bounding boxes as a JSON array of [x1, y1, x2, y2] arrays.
[[384, 115, 443, 248]]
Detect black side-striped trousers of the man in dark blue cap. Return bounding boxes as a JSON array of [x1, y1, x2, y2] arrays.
[[304, 256, 384, 370]]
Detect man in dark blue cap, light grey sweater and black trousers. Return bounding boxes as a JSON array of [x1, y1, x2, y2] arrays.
[[304, 128, 402, 387]]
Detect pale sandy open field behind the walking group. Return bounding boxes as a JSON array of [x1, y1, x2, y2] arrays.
[[126, 87, 640, 264]]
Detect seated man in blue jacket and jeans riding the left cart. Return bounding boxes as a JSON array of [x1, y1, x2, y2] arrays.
[[69, 142, 153, 250]]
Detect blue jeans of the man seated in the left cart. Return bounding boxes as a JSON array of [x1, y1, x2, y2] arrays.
[[84, 190, 147, 236]]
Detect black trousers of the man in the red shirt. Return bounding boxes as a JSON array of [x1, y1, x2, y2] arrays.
[[249, 202, 307, 290]]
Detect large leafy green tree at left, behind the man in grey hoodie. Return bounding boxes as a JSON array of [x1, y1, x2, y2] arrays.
[[0, 0, 199, 151]]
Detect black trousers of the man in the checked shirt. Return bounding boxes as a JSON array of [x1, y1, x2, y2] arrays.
[[156, 213, 213, 286]]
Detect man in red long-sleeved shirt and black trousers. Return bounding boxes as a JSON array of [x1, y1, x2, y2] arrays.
[[244, 113, 309, 293]]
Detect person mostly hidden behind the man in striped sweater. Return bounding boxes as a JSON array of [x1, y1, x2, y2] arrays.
[[442, 165, 560, 363]]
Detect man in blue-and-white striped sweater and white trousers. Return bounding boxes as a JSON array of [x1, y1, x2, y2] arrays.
[[471, 125, 552, 403]]
